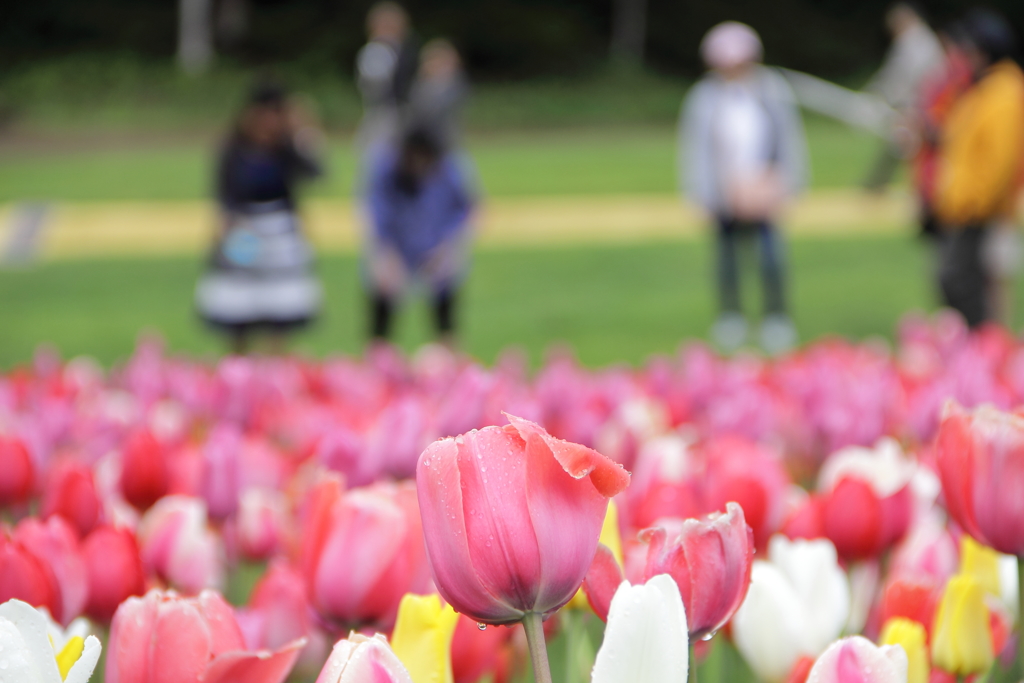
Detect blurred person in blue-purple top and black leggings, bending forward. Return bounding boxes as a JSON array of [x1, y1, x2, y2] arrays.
[[365, 128, 475, 345]]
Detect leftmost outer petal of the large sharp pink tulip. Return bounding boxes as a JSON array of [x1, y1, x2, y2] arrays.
[[416, 430, 522, 624]]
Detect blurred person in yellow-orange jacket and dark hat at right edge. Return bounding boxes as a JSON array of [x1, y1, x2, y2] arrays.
[[935, 9, 1024, 328]]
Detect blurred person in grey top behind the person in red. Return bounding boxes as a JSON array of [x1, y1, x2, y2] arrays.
[[864, 2, 945, 191]]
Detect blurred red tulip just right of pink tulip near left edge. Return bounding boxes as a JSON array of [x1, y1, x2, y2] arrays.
[[82, 526, 145, 624]]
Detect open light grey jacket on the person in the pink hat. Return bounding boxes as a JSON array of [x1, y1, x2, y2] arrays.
[[679, 67, 808, 214]]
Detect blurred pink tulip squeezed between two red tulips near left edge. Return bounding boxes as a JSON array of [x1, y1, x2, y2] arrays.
[[11, 517, 89, 625]]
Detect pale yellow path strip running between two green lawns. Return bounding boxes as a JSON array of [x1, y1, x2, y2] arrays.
[[0, 189, 913, 259]]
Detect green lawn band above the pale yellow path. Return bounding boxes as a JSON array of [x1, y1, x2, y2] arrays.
[[0, 118, 878, 203]]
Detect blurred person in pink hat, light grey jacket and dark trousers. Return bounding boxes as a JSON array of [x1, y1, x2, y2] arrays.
[[680, 22, 807, 353]]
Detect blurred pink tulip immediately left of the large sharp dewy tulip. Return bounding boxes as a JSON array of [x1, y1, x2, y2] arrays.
[[302, 477, 427, 628]]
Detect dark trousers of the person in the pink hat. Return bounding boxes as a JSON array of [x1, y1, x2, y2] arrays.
[[718, 217, 785, 314]]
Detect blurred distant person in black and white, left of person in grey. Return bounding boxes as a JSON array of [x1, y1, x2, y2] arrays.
[[355, 2, 419, 153]]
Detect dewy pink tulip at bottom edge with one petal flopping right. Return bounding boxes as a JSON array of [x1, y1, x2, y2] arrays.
[[105, 591, 303, 683]]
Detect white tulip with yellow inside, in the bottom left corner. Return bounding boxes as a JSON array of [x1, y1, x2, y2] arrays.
[[0, 600, 102, 683]]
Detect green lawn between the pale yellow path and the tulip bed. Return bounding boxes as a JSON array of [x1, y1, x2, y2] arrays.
[[0, 237, 958, 374]]
